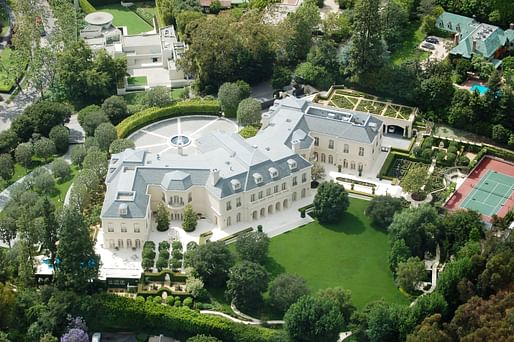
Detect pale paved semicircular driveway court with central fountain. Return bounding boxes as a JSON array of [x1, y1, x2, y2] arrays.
[[128, 115, 238, 158]]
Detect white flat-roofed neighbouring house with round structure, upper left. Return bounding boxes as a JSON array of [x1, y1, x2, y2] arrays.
[[80, 12, 191, 92]]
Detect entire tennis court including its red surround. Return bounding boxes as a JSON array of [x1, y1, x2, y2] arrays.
[[445, 157, 514, 220]]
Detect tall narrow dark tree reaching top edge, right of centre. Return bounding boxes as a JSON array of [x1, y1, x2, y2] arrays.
[[350, 0, 384, 76]]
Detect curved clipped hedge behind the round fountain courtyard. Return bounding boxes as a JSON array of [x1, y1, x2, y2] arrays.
[[116, 100, 220, 138]]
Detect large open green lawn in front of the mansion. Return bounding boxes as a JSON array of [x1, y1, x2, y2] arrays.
[[267, 198, 408, 308]]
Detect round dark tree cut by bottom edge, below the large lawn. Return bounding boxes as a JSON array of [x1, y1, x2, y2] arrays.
[[284, 296, 343, 342]]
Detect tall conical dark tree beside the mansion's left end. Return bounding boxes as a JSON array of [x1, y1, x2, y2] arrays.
[[55, 207, 100, 292]]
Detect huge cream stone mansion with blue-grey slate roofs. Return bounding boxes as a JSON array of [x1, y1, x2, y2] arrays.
[[101, 98, 382, 248]]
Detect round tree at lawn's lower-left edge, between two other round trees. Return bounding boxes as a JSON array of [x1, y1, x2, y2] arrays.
[[225, 261, 268, 309]]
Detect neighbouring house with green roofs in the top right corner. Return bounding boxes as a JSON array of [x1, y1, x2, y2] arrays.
[[436, 12, 514, 67]]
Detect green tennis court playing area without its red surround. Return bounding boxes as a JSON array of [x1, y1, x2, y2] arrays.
[[461, 171, 514, 216]]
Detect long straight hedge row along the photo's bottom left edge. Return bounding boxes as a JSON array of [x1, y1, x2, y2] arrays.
[[87, 294, 276, 342]]
